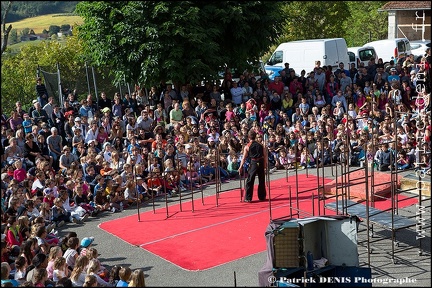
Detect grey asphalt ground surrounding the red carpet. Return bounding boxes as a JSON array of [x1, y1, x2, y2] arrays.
[[59, 167, 431, 287]]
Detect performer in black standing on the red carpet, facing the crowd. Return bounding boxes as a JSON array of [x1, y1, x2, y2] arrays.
[[238, 130, 267, 202]]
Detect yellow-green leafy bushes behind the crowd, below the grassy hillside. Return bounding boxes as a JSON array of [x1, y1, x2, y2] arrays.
[[1, 37, 84, 111]]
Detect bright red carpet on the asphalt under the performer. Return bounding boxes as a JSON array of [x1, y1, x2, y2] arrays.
[[100, 175, 418, 271]]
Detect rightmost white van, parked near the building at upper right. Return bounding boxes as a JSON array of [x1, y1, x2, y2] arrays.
[[363, 38, 411, 65]]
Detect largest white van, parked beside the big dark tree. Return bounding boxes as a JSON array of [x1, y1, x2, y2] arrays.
[[265, 38, 349, 80]]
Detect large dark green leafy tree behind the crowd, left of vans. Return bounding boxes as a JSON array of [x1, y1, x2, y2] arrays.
[[76, 1, 283, 86]]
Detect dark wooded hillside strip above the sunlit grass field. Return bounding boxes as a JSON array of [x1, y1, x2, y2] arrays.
[[1, 1, 80, 23]]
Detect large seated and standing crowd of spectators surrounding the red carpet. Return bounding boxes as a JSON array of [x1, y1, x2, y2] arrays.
[[1, 49, 431, 286]]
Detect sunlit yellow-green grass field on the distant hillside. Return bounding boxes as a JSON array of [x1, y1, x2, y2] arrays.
[[6, 14, 84, 35]]
